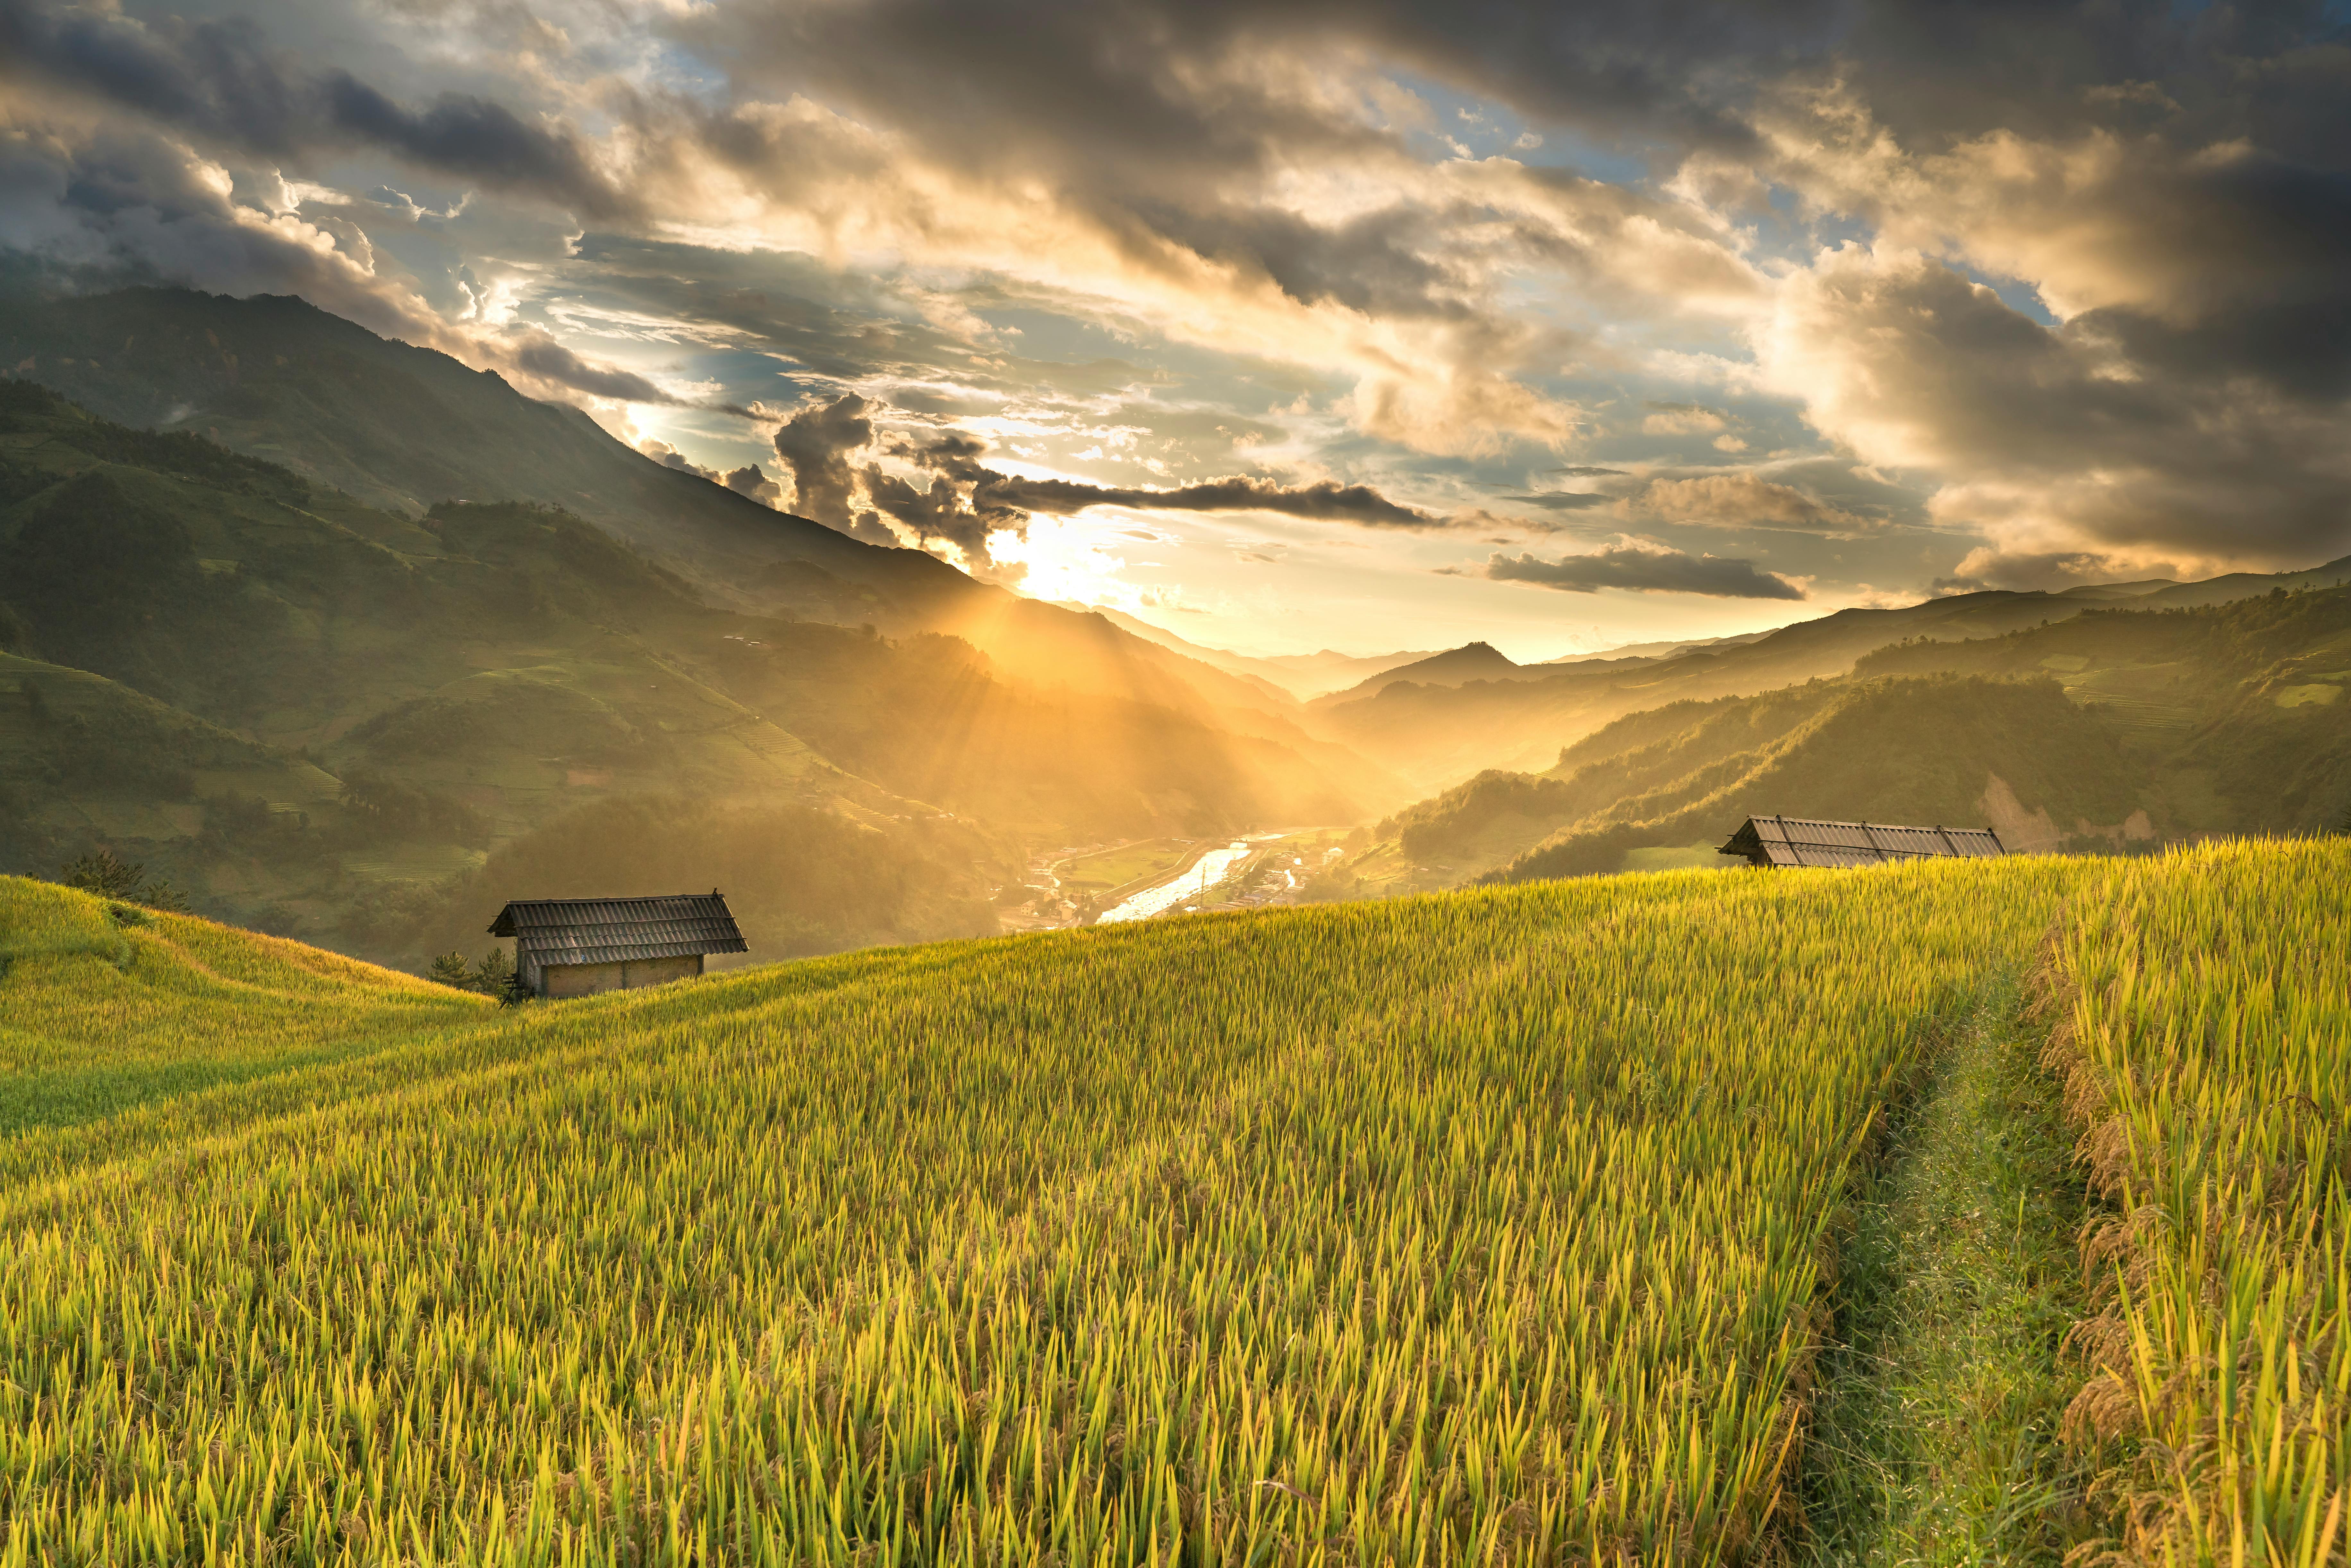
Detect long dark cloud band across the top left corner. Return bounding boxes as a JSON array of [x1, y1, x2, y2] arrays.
[[0, 0, 635, 216]]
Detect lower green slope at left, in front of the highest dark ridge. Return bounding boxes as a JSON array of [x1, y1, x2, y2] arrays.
[[0, 383, 1364, 961]]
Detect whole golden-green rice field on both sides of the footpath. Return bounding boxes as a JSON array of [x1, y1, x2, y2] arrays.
[[0, 844, 2351, 1568]]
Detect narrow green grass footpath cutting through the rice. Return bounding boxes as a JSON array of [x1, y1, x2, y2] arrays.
[[1806, 983, 2085, 1566]]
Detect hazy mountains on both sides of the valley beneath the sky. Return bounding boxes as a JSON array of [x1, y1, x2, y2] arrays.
[[14, 289, 2351, 966]]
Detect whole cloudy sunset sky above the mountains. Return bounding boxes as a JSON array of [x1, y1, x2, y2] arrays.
[[0, 0, 2351, 660]]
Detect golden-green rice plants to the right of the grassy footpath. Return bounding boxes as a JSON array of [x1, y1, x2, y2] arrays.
[[2045, 839, 2351, 1568]]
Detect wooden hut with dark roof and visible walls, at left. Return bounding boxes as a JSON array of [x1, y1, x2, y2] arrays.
[[489, 889, 750, 997]]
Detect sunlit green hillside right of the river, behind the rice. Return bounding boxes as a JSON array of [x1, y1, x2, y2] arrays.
[[1331, 581, 2351, 893]]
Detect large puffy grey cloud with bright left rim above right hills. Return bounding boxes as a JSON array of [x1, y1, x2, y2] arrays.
[[1780, 251, 2351, 581]]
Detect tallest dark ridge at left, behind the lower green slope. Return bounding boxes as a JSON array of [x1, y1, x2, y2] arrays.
[[0, 289, 1411, 785]]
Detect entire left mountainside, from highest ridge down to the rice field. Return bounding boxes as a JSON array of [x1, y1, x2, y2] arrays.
[[0, 292, 1399, 961]]
